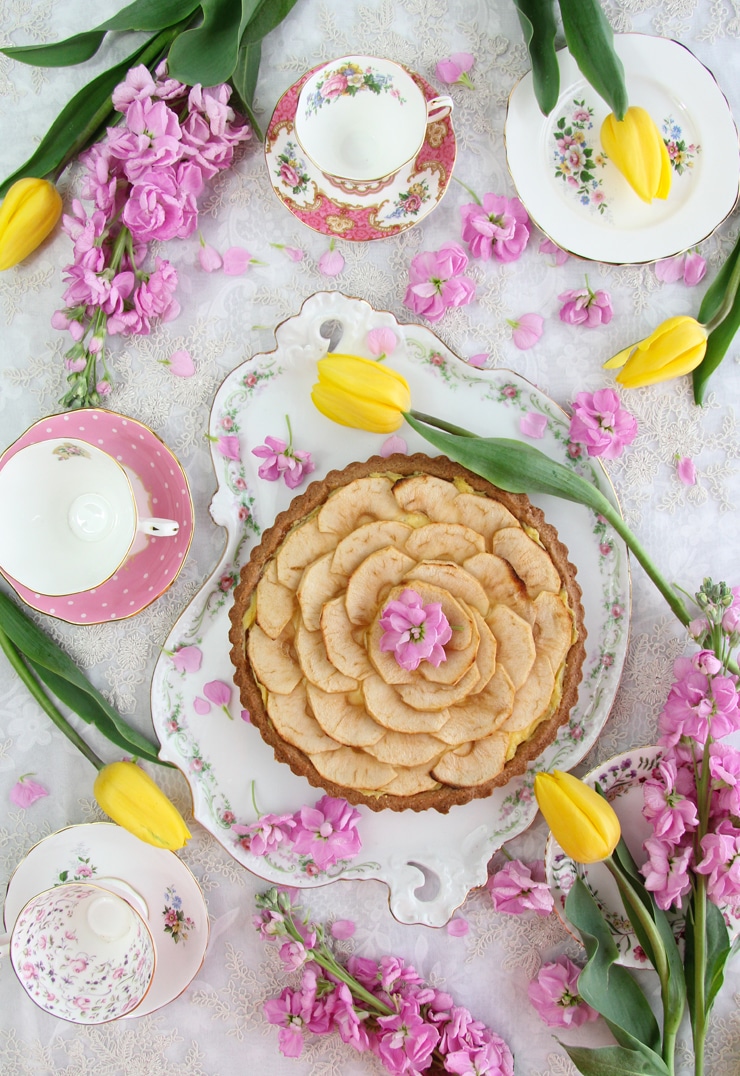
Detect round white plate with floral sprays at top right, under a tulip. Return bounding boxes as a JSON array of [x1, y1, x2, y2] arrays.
[[504, 33, 740, 265]]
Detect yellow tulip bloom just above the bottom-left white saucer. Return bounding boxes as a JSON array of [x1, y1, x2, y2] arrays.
[[94, 762, 190, 851]]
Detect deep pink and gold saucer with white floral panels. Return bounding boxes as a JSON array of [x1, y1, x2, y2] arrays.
[[265, 65, 457, 242]]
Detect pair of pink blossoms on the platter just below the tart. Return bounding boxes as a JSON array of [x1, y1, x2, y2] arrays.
[[231, 796, 362, 870]]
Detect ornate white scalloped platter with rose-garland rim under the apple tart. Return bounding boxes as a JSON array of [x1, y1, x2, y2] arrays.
[[152, 292, 629, 926]]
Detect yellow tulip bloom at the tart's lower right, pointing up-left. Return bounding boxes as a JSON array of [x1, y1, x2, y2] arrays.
[[535, 769, 621, 863]]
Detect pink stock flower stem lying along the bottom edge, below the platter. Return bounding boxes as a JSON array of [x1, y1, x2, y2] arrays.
[[260, 886, 514, 1076]]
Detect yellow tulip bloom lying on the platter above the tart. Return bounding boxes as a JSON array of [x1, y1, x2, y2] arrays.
[[311, 354, 411, 434]]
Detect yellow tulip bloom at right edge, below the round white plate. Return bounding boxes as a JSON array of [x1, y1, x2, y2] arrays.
[[603, 314, 709, 388]]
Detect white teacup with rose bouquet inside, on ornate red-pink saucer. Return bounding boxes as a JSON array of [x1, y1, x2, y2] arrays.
[[295, 56, 453, 193]]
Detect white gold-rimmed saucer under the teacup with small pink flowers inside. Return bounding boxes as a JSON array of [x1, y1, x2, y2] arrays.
[[3, 822, 210, 1019]]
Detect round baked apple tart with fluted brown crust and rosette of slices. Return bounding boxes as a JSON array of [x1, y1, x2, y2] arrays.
[[230, 455, 585, 811]]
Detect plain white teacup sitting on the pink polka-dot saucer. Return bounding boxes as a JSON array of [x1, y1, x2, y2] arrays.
[[0, 438, 179, 595]]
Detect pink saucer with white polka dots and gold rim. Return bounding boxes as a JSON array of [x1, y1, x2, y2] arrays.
[[0, 408, 194, 624]]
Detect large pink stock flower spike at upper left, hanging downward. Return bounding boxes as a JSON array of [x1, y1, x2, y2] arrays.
[[52, 62, 252, 407]]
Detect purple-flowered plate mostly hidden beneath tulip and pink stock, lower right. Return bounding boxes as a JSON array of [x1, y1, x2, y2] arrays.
[[544, 747, 740, 967]]
